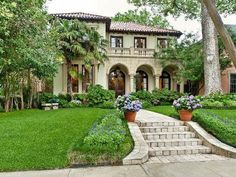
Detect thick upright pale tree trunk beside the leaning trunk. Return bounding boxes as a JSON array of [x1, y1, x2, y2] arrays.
[[202, 1, 221, 95]]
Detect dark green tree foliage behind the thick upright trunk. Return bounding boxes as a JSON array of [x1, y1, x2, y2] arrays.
[[155, 31, 236, 95]]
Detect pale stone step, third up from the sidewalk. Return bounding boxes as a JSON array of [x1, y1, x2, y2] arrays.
[[142, 132, 196, 140]]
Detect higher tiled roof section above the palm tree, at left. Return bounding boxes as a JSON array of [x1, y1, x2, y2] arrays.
[[51, 12, 111, 21]]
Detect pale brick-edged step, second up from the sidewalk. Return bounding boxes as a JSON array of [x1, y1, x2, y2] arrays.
[[146, 138, 202, 147]]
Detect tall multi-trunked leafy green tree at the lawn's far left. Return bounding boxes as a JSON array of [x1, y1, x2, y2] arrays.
[[0, 0, 57, 111]]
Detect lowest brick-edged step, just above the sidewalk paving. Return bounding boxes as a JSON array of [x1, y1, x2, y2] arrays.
[[148, 145, 211, 157]]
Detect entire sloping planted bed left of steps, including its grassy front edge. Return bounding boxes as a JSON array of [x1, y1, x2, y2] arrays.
[[70, 111, 133, 166]]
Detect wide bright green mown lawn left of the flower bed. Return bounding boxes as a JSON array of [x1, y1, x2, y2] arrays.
[[0, 108, 111, 171]]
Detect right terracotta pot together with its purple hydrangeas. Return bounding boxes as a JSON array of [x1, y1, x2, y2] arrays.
[[173, 95, 202, 121]]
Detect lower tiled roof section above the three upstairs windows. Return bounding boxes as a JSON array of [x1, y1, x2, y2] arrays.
[[110, 22, 182, 36]]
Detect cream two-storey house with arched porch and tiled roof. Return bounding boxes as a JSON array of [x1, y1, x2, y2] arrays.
[[53, 13, 184, 95]]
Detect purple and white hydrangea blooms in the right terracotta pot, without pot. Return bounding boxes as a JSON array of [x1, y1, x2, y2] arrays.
[[173, 95, 202, 111]]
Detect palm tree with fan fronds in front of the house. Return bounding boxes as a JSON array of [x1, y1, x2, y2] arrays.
[[55, 19, 107, 96]]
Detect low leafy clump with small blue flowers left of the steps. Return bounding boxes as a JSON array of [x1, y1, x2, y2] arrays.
[[84, 113, 126, 152]]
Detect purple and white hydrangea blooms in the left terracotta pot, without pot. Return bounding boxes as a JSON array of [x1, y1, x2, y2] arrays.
[[115, 95, 142, 112]]
